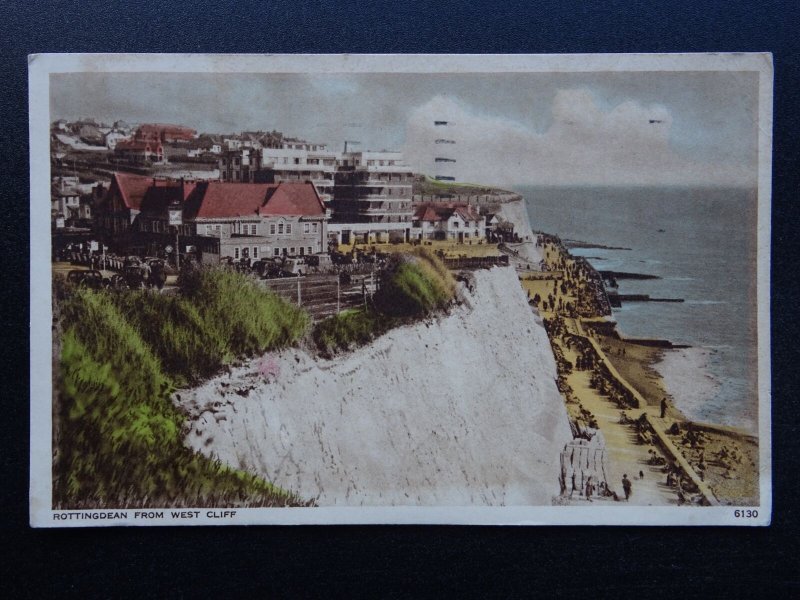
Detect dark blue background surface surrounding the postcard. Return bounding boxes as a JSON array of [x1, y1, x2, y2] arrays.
[[0, 0, 800, 598]]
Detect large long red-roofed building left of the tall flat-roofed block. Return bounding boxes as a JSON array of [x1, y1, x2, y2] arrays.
[[95, 173, 327, 263]]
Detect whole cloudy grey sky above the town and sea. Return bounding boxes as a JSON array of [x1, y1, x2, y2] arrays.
[[50, 71, 758, 186]]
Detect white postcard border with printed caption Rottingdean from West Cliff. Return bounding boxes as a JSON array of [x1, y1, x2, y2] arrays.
[[29, 53, 773, 527]]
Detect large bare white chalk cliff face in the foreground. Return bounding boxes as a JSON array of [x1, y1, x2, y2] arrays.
[[175, 268, 572, 506]]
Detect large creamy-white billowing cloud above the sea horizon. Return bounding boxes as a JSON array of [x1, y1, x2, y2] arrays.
[[405, 88, 755, 186]]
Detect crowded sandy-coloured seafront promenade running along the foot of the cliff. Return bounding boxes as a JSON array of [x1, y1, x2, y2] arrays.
[[512, 236, 718, 505]]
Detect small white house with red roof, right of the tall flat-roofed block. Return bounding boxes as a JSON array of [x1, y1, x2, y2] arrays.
[[413, 202, 486, 243]]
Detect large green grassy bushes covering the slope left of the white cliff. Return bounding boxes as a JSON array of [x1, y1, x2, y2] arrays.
[[53, 270, 308, 508]]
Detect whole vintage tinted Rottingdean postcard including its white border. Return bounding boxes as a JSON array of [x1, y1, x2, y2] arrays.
[[29, 54, 773, 527]]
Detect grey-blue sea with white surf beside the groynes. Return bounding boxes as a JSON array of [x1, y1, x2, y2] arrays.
[[516, 187, 758, 433]]
